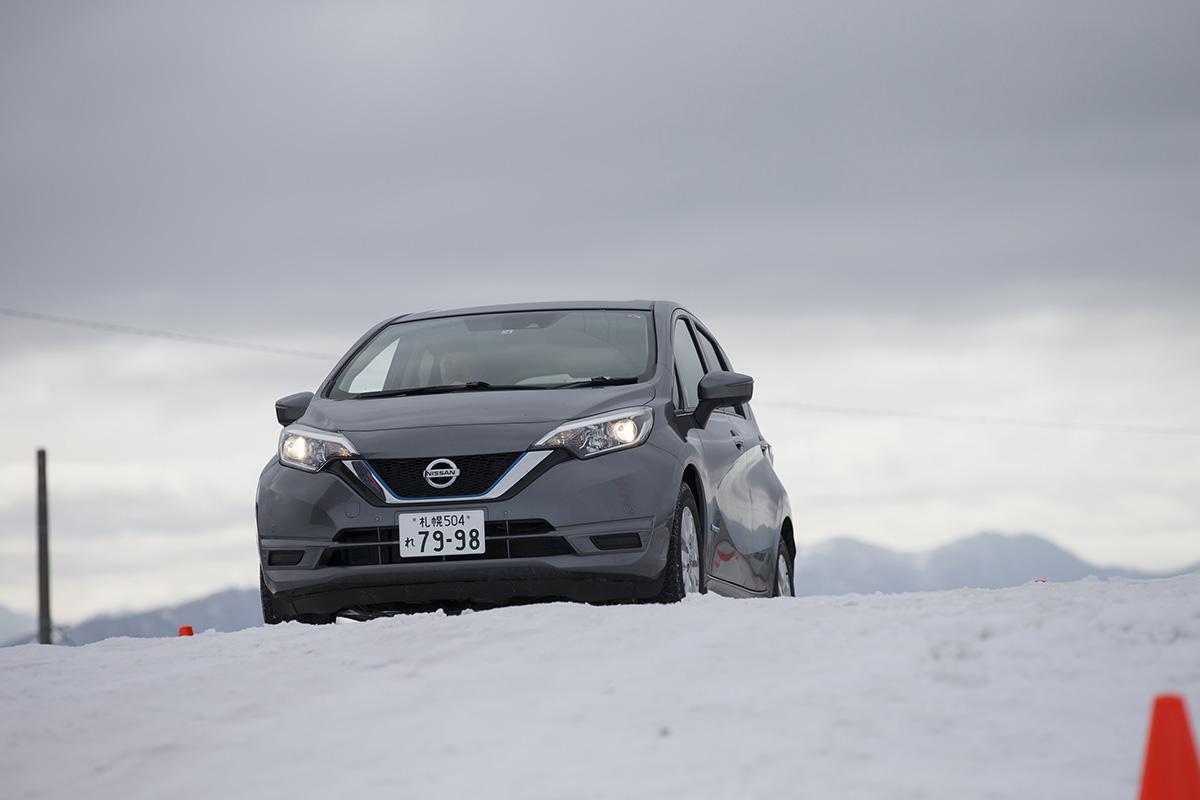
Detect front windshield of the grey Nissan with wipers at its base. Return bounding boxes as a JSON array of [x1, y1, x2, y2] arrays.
[[329, 308, 654, 399]]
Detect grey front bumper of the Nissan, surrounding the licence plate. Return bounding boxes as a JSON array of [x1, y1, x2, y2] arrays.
[[257, 446, 679, 614]]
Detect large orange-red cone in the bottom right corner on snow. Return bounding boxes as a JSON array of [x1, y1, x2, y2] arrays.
[[1139, 694, 1200, 800]]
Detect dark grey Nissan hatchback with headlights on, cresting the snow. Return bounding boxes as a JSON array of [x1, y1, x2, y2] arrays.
[[256, 301, 796, 622]]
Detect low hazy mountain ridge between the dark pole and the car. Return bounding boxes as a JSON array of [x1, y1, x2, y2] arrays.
[[65, 589, 263, 644]]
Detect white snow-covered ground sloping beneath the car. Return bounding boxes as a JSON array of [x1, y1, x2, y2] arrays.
[[0, 576, 1200, 800]]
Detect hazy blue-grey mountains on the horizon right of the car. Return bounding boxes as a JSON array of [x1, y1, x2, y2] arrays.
[[796, 534, 1200, 595]]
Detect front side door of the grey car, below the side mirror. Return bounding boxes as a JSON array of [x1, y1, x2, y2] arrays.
[[672, 317, 755, 591]]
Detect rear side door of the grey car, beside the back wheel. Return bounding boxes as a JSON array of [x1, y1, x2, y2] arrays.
[[692, 321, 779, 591]]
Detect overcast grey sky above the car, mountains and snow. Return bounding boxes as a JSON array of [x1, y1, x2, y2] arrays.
[[0, 0, 1200, 618]]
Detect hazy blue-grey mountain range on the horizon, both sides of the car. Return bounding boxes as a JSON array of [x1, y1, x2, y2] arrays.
[[11, 534, 1200, 644]]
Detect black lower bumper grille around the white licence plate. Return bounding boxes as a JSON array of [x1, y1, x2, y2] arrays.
[[320, 519, 575, 567]]
